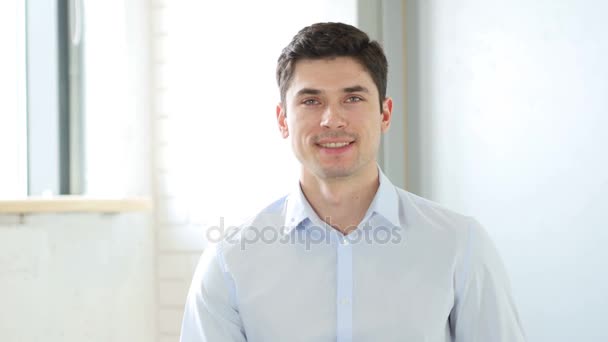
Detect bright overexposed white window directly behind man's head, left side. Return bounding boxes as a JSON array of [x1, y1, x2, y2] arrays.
[[153, 0, 357, 228]]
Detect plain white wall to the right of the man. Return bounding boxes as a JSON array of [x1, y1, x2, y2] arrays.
[[407, 0, 608, 342]]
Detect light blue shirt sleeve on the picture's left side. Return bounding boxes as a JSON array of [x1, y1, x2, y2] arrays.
[[180, 245, 247, 342]]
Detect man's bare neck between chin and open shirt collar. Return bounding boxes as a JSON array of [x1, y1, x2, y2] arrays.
[[300, 165, 379, 235]]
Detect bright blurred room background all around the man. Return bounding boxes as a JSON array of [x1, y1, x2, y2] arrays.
[[0, 0, 608, 342]]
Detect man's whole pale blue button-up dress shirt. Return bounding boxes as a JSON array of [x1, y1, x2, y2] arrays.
[[181, 172, 525, 342]]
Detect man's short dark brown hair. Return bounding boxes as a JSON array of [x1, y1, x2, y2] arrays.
[[276, 23, 388, 111]]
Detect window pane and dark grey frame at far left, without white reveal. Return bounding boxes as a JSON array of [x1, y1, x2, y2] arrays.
[[0, 0, 81, 198]]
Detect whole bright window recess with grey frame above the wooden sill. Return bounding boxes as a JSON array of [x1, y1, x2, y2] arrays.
[[0, 0, 150, 198]]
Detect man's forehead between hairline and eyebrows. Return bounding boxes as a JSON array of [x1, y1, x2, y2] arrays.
[[287, 57, 377, 95]]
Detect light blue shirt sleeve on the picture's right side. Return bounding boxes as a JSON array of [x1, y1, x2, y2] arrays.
[[450, 220, 525, 342]]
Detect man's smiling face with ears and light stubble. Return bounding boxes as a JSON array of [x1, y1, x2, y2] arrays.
[[277, 57, 392, 179]]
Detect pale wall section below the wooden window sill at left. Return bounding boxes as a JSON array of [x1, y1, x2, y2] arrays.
[[0, 213, 156, 342]]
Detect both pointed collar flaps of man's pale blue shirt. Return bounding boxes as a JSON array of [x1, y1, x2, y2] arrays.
[[284, 167, 400, 234]]
